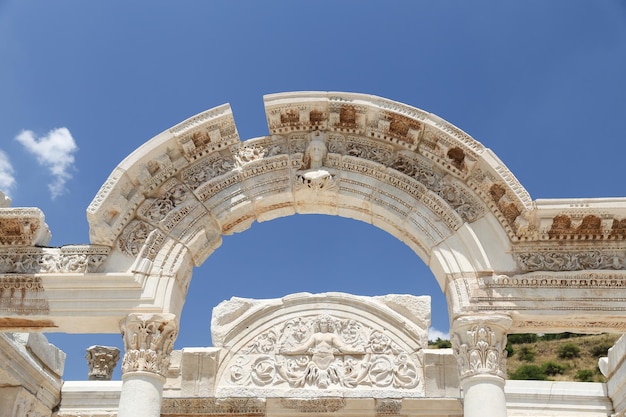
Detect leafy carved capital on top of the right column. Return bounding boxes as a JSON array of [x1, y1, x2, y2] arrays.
[[450, 316, 512, 380]]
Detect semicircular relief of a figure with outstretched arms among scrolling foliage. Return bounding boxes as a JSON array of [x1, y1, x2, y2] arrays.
[[225, 315, 422, 389]]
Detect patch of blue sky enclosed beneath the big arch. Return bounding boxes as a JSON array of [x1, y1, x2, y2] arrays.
[[176, 215, 449, 346]]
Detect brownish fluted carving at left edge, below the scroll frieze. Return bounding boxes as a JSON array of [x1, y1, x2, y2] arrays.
[[0, 275, 49, 315]]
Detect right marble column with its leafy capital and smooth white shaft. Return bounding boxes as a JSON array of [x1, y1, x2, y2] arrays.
[[450, 315, 512, 417]]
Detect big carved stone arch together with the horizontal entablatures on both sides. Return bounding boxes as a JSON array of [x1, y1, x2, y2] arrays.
[[0, 92, 626, 415]]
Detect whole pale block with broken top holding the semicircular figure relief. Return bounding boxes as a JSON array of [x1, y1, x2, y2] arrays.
[[212, 293, 430, 398]]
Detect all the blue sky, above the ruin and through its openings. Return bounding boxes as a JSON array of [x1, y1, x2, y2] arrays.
[[0, 0, 626, 380]]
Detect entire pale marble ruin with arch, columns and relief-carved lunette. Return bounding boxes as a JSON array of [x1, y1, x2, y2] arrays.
[[0, 92, 626, 417]]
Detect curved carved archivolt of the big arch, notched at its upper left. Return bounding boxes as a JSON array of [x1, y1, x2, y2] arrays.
[[88, 92, 532, 294]]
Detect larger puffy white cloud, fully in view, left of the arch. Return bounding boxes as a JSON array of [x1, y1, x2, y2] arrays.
[[15, 127, 78, 199]]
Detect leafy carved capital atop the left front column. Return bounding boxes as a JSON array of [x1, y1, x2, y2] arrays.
[[120, 314, 178, 377]]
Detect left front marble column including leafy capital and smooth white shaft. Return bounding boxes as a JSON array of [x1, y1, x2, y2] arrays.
[[117, 314, 178, 417]]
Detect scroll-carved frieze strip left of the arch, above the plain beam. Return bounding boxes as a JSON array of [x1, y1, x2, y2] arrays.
[[0, 245, 111, 274]]
